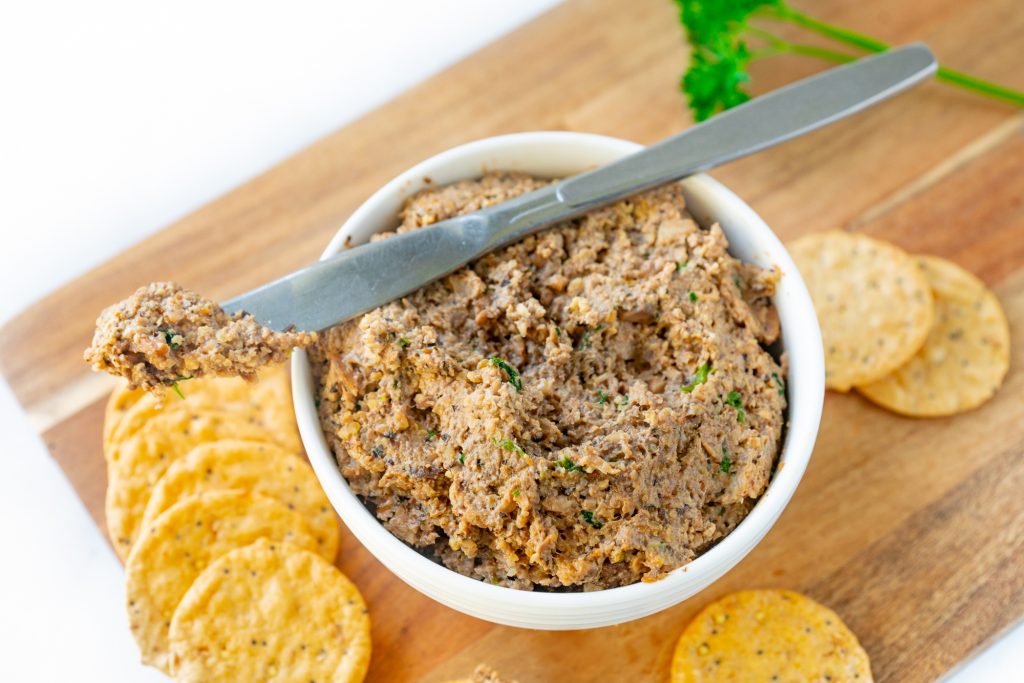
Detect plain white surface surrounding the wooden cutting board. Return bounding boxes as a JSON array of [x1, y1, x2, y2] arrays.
[[0, 0, 1024, 683]]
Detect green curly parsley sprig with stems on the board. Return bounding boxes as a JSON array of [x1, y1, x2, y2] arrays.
[[676, 0, 1024, 121]]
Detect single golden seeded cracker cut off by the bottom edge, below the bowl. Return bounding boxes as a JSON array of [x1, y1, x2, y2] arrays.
[[672, 590, 871, 683]]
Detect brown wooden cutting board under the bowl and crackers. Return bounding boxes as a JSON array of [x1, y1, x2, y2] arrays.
[[0, 0, 1024, 683]]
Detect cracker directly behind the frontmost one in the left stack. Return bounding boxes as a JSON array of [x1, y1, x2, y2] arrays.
[[125, 490, 323, 672]]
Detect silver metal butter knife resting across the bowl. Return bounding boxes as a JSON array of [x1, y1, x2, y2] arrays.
[[223, 44, 937, 331]]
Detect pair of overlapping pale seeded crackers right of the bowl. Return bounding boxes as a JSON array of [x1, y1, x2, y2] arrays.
[[790, 230, 1010, 417]]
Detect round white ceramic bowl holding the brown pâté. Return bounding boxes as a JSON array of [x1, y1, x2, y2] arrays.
[[292, 132, 824, 630]]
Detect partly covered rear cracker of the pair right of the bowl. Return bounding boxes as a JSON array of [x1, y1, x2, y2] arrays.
[[857, 256, 1010, 417]]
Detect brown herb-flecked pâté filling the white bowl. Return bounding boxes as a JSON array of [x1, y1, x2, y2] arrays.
[[310, 173, 785, 590]]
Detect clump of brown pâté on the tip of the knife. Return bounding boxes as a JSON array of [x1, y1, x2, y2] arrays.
[[84, 283, 316, 391]]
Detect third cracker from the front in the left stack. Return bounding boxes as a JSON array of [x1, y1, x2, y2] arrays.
[[142, 440, 338, 561]]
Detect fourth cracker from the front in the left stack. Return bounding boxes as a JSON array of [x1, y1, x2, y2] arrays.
[[106, 411, 271, 559]]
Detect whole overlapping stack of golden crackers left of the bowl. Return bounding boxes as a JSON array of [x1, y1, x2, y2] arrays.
[[103, 367, 371, 682]]
